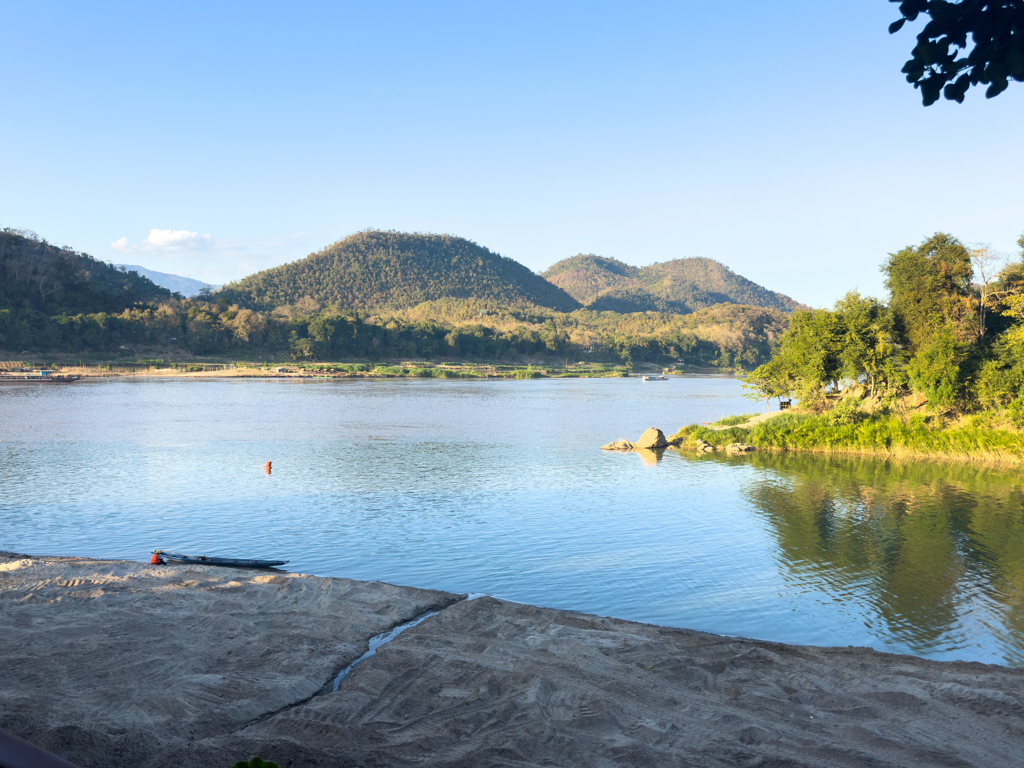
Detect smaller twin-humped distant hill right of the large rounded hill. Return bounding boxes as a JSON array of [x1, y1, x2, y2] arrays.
[[543, 254, 800, 314]]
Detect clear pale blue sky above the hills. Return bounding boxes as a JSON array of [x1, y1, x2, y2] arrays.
[[0, 0, 1024, 306]]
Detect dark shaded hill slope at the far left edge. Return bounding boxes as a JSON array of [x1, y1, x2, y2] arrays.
[[0, 228, 171, 315]]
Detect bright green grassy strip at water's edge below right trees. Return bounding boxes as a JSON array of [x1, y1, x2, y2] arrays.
[[669, 413, 1024, 464]]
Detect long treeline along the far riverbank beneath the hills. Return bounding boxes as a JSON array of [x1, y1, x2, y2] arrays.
[[0, 292, 785, 369]]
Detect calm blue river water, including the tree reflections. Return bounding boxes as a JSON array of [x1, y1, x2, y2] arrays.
[[0, 377, 1024, 666]]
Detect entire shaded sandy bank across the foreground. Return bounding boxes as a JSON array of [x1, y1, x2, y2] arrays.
[[0, 560, 1024, 768]]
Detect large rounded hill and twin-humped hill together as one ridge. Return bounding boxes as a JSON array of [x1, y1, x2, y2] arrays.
[[218, 229, 802, 314]]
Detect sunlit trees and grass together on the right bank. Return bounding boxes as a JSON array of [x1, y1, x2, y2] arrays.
[[674, 233, 1024, 462]]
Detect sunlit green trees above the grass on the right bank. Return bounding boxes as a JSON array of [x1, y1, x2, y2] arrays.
[[748, 233, 1024, 426]]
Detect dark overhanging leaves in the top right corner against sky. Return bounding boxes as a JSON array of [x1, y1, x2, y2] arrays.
[[889, 0, 1024, 106]]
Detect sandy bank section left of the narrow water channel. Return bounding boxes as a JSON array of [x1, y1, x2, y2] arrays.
[[0, 558, 459, 768]]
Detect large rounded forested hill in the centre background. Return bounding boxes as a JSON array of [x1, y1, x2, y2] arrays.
[[218, 230, 580, 312]]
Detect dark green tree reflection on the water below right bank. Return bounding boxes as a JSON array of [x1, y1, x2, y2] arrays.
[[671, 454, 1024, 664]]
